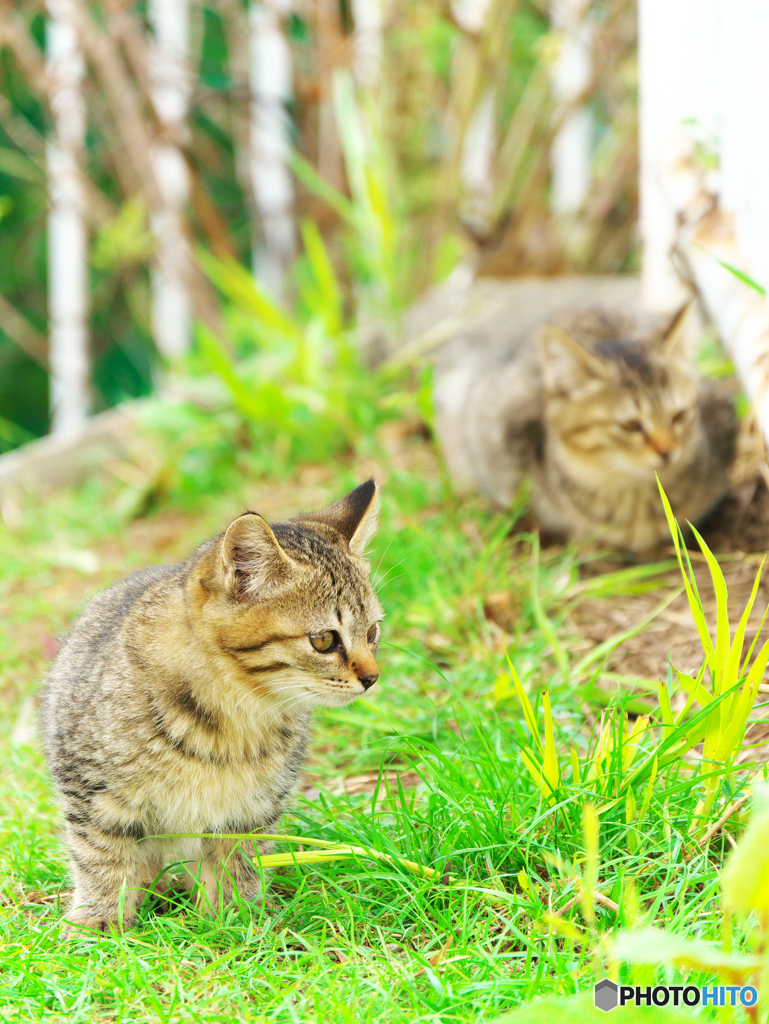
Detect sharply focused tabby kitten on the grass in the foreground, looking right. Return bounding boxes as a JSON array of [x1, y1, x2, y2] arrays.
[[41, 480, 382, 931]]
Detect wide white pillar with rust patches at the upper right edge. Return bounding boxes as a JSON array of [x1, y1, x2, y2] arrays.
[[639, 0, 769, 442]]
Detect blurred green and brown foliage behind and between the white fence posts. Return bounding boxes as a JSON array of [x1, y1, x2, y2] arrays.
[[0, 0, 637, 451]]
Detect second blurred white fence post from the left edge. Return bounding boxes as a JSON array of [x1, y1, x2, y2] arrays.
[[147, 0, 191, 361]]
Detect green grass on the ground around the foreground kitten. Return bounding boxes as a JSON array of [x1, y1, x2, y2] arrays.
[[0, 419, 756, 1024]]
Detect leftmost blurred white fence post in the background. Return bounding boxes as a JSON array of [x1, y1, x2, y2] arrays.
[[46, 0, 90, 434]]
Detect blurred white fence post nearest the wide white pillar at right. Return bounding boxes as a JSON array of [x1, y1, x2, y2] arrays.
[[550, 0, 593, 215]]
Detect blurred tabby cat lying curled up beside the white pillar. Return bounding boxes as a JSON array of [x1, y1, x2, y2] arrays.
[[435, 308, 737, 552]]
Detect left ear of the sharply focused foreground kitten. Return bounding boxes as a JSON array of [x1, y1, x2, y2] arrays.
[[221, 512, 297, 601]]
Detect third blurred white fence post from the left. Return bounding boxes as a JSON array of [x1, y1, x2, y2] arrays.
[[249, 0, 296, 298]]
